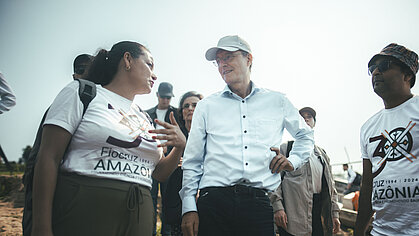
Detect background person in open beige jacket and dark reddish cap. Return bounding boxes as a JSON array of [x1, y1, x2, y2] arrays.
[[270, 107, 340, 236]]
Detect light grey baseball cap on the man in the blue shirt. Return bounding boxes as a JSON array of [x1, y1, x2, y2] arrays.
[[205, 35, 252, 61]]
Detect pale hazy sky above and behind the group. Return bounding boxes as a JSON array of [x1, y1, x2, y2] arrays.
[[0, 0, 419, 171]]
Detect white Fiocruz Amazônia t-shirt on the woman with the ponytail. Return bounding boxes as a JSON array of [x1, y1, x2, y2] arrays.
[[44, 81, 162, 188]]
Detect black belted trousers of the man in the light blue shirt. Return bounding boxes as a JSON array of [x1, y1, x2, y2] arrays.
[[197, 185, 274, 236]]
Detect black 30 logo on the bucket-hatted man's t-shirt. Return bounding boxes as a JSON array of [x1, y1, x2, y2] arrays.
[[369, 121, 416, 176]]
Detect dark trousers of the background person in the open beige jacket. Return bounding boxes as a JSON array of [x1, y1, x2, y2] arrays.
[[278, 193, 324, 236]]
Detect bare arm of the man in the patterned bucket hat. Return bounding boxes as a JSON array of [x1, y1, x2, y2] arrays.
[[354, 159, 373, 235]]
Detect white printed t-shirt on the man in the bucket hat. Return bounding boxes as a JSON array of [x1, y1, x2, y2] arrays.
[[360, 96, 419, 235]]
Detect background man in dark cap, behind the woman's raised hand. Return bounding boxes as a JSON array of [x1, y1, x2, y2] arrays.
[[146, 82, 178, 236]]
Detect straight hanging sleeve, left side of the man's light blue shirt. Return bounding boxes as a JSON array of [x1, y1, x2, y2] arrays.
[[179, 101, 207, 215]]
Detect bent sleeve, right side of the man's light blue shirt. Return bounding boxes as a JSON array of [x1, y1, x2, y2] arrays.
[[284, 98, 314, 170]]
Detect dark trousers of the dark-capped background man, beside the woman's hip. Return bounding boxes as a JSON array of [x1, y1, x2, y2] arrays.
[[151, 178, 170, 236]]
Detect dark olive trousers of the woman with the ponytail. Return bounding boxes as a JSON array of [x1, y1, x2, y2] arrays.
[[52, 174, 153, 236]]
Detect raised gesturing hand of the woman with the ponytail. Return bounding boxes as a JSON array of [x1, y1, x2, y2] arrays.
[[148, 112, 186, 149]]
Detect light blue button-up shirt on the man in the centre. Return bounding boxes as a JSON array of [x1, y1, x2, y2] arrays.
[[179, 82, 314, 213]]
